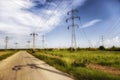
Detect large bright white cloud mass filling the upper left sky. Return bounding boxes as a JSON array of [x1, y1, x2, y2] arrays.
[[0, 0, 85, 35]]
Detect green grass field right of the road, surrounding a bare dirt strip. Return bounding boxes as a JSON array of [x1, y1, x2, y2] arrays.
[[30, 50, 120, 80]]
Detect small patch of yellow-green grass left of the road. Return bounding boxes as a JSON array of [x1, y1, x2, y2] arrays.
[[0, 50, 17, 61]]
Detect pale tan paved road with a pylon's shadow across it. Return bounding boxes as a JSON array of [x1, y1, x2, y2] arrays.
[[0, 51, 73, 80]]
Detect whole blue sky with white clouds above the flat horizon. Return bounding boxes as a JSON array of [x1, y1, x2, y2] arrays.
[[0, 0, 120, 48]]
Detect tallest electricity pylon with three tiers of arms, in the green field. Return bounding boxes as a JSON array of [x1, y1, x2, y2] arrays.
[[66, 9, 80, 50]]
